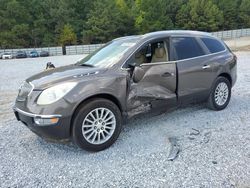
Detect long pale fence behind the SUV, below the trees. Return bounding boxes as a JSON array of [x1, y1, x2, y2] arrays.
[[0, 28, 250, 56]]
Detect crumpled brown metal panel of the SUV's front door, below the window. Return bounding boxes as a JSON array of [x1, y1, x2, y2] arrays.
[[128, 62, 177, 116]]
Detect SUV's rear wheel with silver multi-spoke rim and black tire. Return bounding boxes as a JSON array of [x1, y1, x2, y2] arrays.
[[207, 77, 231, 111]]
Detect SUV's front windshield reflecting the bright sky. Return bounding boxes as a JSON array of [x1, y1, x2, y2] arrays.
[[77, 38, 138, 67]]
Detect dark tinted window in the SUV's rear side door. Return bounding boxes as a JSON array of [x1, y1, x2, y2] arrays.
[[173, 37, 205, 60]]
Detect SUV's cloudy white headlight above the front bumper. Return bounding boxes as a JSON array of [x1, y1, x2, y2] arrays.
[[37, 82, 76, 105]]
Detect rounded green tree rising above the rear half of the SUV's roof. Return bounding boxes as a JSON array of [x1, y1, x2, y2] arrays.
[[176, 0, 223, 31]]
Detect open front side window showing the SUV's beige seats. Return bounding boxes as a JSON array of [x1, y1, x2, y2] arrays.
[[128, 40, 169, 66]]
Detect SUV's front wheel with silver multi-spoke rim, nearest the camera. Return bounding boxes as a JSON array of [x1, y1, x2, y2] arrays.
[[72, 98, 122, 151]]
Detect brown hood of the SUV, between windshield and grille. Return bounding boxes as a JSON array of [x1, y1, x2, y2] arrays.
[[26, 65, 105, 89]]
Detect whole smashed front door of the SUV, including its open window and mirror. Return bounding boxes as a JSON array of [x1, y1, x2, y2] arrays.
[[127, 40, 177, 116]]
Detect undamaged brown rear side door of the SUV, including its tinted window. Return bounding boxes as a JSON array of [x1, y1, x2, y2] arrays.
[[171, 36, 214, 103]]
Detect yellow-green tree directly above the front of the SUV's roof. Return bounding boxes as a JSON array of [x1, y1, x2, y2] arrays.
[[135, 0, 173, 33]]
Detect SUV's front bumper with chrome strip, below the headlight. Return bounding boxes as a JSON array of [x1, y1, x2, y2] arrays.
[[13, 107, 70, 140]]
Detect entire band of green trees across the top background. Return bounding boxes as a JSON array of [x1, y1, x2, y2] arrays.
[[0, 0, 250, 48]]
